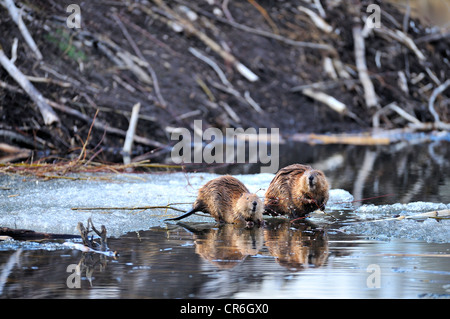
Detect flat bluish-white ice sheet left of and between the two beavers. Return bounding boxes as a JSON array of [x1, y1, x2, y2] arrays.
[[0, 173, 273, 236]]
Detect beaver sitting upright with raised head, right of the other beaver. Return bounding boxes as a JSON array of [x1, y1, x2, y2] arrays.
[[264, 164, 329, 218]]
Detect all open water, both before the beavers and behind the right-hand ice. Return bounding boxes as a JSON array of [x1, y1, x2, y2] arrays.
[[0, 142, 450, 299]]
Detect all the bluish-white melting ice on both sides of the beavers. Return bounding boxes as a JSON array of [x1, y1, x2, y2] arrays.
[[0, 173, 450, 242]]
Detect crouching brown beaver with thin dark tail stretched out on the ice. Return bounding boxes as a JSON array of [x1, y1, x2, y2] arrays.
[[166, 175, 264, 227]]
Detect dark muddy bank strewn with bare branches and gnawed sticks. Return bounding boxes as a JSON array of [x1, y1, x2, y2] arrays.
[[0, 0, 450, 162]]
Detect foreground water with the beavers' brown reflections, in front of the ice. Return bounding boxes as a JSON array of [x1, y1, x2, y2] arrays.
[[0, 221, 450, 299]]
